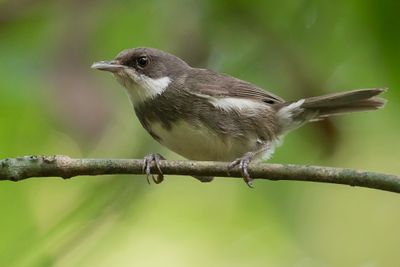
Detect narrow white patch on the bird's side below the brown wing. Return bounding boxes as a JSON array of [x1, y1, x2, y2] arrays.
[[209, 97, 268, 111]]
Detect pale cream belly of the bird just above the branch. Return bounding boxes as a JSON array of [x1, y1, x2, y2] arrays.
[[151, 121, 257, 161]]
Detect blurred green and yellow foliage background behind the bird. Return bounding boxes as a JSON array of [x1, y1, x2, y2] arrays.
[[0, 0, 400, 267]]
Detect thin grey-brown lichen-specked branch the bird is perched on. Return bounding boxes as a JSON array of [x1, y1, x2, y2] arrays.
[[0, 156, 400, 193]]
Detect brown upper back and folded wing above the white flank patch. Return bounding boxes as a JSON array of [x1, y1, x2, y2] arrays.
[[186, 69, 285, 105]]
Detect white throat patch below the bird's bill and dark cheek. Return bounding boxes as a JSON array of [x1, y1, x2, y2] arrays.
[[115, 71, 171, 104]]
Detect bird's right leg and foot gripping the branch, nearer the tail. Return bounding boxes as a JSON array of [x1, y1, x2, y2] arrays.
[[228, 142, 272, 188]]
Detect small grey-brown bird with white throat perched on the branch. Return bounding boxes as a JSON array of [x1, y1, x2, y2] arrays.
[[91, 47, 386, 187]]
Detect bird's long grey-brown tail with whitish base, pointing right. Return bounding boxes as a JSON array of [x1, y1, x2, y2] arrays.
[[278, 88, 387, 130]]
